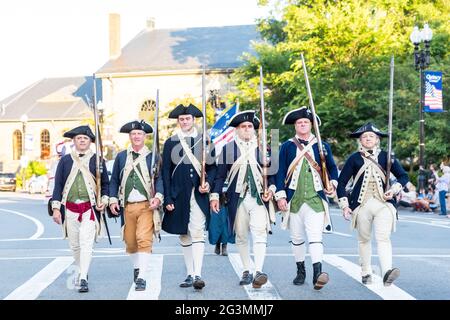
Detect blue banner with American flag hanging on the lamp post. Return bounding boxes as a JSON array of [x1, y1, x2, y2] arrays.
[[423, 71, 444, 112]]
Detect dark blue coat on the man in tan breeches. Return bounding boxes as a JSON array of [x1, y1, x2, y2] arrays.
[[109, 150, 164, 226]]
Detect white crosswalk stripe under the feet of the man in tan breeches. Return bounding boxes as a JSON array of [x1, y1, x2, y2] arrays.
[[127, 254, 163, 300]]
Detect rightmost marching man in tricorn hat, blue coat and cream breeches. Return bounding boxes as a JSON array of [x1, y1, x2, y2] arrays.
[[337, 123, 408, 286]]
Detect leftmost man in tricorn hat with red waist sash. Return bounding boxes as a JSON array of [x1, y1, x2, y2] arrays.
[[51, 126, 108, 292]]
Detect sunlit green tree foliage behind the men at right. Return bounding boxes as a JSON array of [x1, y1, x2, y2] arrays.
[[234, 0, 450, 165]]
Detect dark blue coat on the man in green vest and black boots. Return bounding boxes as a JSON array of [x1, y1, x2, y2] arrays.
[[276, 140, 338, 202]]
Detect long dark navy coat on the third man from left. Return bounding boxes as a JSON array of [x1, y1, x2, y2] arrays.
[[162, 134, 216, 234]]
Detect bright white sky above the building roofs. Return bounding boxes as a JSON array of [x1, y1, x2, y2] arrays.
[[0, 0, 268, 101]]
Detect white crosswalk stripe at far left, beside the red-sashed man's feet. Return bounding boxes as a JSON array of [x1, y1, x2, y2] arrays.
[[5, 257, 74, 300]]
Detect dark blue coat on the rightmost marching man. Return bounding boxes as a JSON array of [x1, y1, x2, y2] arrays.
[[337, 151, 409, 210]]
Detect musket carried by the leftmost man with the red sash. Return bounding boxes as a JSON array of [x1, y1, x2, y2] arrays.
[[92, 74, 112, 244]]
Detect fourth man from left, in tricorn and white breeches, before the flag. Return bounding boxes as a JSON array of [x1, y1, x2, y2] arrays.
[[210, 111, 275, 288]]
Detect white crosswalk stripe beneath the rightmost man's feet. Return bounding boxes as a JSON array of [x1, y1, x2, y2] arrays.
[[323, 254, 416, 300]]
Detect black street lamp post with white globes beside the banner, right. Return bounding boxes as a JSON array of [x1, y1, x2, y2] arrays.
[[409, 23, 433, 192]]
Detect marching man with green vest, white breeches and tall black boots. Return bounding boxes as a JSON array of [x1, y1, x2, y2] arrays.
[[275, 107, 338, 290]]
